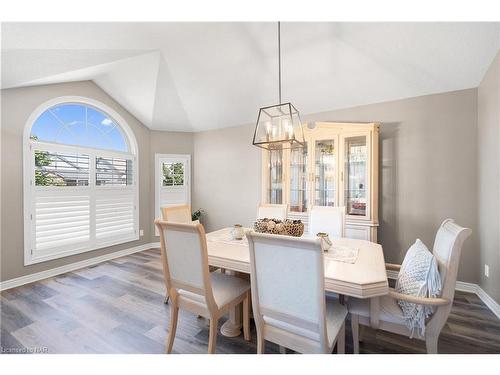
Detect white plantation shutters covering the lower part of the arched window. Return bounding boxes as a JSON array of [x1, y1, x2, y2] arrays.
[[29, 144, 139, 262]]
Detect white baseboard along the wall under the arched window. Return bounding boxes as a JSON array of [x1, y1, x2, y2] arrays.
[[0, 243, 154, 291]]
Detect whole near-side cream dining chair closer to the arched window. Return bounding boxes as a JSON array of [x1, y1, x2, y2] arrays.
[[155, 220, 250, 353]]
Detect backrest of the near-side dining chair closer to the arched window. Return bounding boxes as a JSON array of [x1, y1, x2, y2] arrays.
[[155, 220, 213, 305]]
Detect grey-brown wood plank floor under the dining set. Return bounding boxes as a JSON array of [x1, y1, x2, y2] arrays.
[[0, 249, 500, 354]]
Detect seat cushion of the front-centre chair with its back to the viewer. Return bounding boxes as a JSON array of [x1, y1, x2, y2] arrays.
[[264, 298, 347, 345]]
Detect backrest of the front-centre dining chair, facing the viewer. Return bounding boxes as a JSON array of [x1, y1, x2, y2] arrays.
[[247, 232, 327, 345]]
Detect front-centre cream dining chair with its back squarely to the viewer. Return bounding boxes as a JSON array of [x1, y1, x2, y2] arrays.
[[247, 232, 347, 354]]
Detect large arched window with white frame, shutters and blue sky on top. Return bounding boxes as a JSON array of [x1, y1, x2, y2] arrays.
[[24, 97, 139, 264]]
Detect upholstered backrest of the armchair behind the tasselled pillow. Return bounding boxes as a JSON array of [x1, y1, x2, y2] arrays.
[[433, 219, 472, 300]]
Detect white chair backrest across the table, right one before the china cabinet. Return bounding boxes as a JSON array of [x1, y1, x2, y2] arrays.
[[309, 206, 345, 237]]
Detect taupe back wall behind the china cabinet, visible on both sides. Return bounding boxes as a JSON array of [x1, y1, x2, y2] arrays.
[[194, 89, 479, 282]]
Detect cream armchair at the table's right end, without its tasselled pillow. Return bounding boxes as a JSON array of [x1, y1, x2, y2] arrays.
[[349, 219, 472, 354]]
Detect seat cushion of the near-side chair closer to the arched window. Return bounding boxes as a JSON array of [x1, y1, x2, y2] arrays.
[[178, 272, 250, 308]]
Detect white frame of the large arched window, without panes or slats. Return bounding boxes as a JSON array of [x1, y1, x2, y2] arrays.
[[23, 96, 139, 266]]
